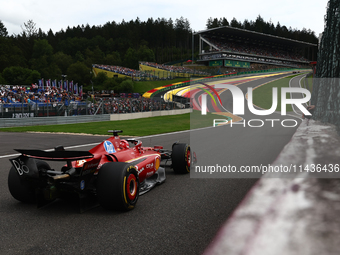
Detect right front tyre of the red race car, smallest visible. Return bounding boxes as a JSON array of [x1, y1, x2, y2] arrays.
[[171, 143, 191, 174]]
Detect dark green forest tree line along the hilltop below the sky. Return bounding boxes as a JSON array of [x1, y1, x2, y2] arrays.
[[0, 16, 317, 91]]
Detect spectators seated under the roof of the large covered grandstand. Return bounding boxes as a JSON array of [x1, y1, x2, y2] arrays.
[[204, 35, 307, 61]]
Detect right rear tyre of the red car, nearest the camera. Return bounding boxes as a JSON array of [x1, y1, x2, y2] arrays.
[[97, 162, 140, 211]]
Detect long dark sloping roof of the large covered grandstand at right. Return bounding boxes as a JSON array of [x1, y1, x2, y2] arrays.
[[195, 26, 317, 47]]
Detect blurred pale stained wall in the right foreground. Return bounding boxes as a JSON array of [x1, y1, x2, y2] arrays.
[[203, 119, 340, 255]]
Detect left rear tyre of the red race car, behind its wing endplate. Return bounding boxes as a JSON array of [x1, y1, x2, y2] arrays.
[[8, 160, 51, 203]]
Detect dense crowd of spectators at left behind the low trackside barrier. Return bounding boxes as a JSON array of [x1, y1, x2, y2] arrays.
[[0, 84, 178, 115]]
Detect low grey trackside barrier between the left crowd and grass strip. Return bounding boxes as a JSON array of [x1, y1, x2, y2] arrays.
[[0, 108, 191, 128]]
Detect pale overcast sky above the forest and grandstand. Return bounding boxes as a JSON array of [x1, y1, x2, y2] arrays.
[[0, 0, 328, 36]]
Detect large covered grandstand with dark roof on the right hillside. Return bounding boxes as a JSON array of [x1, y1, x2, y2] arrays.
[[195, 26, 318, 69]]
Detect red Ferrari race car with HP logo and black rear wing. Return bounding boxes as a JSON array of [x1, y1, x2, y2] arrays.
[[8, 130, 191, 212]]
